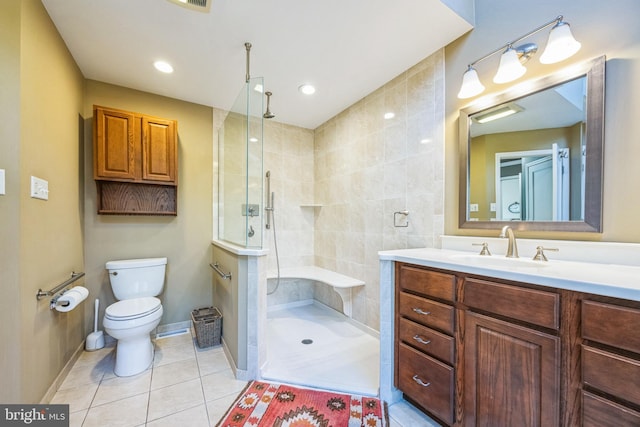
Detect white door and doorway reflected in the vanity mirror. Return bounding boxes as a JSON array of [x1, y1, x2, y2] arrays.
[[496, 144, 570, 221]]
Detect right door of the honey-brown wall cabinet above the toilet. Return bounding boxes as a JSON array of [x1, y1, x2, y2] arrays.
[[142, 116, 177, 183]]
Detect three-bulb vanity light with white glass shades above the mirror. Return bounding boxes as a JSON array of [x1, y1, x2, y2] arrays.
[[458, 15, 581, 99]]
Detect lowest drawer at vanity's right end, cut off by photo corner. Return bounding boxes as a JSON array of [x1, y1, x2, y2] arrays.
[[582, 391, 640, 427]]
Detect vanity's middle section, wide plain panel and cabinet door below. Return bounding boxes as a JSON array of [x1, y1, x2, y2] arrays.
[[463, 279, 560, 427]]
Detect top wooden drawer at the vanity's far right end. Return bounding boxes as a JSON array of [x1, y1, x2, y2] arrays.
[[582, 301, 640, 353]]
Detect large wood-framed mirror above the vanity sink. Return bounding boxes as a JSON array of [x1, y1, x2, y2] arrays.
[[459, 57, 605, 232]]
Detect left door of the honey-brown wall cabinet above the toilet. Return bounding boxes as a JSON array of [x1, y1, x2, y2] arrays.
[[93, 108, 137, 180]]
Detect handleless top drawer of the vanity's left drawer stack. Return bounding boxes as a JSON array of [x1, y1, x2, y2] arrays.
[[399, 264, 456, 301]]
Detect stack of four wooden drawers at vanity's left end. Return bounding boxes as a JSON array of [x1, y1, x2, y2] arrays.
[[395, 264, 456, 425]]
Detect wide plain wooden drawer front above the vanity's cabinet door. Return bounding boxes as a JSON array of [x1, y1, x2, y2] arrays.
[[463, 278, 560, 329]]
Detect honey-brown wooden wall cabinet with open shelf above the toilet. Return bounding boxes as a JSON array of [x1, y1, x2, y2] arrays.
[[93, 106, 178, 215]]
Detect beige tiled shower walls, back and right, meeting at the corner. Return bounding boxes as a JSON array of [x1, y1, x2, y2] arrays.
[[264, 51, 444, 330]]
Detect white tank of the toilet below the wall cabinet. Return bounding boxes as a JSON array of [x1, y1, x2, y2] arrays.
[[105, 258, 167, 300]]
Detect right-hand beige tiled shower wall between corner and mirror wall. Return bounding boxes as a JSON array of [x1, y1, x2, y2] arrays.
[[314, 51, 444, 329]]
